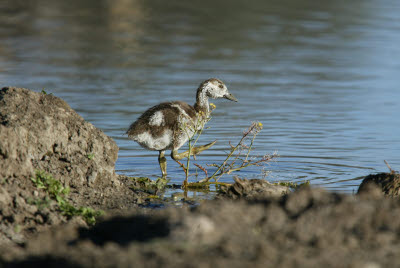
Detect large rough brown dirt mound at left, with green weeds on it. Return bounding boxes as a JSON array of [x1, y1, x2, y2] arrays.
[[0, 87, 141, 245]]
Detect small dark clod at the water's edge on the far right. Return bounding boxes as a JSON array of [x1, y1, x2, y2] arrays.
[[357, 172, 400, 197]]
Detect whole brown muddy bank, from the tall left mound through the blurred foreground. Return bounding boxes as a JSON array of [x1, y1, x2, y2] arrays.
[[0, 88, 400, 267]]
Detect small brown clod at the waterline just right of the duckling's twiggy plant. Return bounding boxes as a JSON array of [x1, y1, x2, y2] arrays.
[[218, 178, 290, 200]]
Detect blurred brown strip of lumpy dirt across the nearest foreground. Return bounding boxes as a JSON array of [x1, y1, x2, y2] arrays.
[[3, 188, 400, 267]]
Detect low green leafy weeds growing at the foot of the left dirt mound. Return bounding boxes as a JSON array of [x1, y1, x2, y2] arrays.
[[31, 170, 103, 225]]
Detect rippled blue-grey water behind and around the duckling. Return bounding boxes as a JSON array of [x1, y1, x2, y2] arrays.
[[0, 0, 400, 192]]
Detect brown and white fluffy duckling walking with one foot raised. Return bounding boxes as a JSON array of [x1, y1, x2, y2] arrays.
[[126, 78, 237, 177]]
